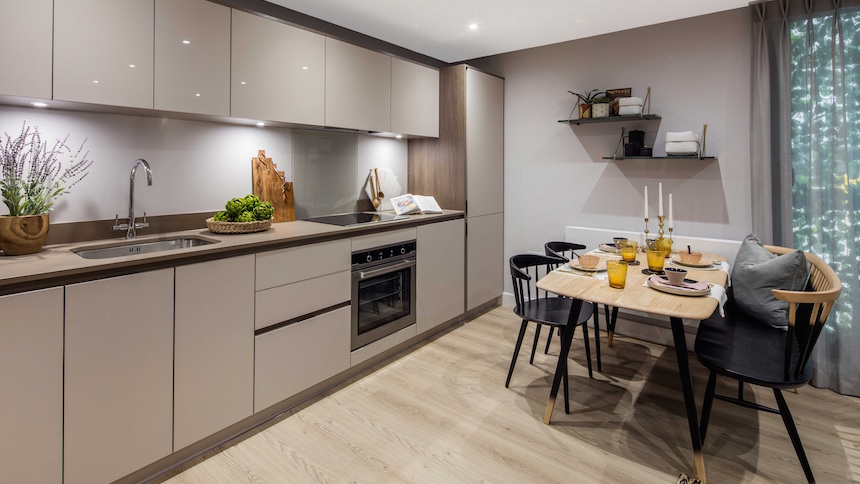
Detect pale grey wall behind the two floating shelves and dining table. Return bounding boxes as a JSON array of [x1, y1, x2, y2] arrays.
[[470, 9, 752, 268]]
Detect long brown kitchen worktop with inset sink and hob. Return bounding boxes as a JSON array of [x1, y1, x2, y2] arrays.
[[0, 210, 464, 295]]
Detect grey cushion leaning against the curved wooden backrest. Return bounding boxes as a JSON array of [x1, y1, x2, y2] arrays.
[[732, 234, 809, 328]]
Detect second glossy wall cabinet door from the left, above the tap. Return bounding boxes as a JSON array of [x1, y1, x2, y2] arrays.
[[53, 0, 155, 108]]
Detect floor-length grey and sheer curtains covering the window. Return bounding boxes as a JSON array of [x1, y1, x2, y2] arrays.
[[750, 0, 860, 395]]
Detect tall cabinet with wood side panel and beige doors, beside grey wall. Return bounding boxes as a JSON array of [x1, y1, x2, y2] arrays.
[[408, 64, 505, 311]]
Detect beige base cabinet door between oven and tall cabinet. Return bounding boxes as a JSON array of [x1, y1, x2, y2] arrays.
[[416, 219, 466, 334]]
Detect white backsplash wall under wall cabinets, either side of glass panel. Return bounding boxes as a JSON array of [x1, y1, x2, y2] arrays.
[[0, 106, 407, 222]]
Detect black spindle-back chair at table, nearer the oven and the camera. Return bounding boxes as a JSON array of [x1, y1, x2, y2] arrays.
[[505, 254, 593, 413]]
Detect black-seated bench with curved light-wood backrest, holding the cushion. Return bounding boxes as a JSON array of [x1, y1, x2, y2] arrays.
[[695, 246, 842, 482]]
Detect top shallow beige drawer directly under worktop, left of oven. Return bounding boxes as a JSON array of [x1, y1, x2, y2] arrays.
[[256, 239, 351, 291]]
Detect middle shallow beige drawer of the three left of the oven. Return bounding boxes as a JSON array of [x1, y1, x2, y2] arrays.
[[254, 271, 351, 329]]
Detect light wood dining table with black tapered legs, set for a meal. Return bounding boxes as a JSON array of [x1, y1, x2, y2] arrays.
[[537, 253, 728, 482]]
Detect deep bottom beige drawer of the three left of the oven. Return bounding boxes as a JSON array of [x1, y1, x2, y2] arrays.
[[254, 307, 350, 412]]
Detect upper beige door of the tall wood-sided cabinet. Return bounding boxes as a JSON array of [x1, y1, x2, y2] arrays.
[[466, 68, 505, 217]]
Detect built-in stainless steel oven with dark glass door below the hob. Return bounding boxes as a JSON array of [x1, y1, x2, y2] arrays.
[[351, 240, 416, 350]]
